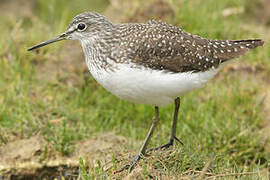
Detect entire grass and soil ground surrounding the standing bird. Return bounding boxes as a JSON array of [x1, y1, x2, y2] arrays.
[[0, 0, 270, 179]]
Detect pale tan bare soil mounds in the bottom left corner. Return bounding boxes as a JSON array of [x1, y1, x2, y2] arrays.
[[0, 133, 126, 179]]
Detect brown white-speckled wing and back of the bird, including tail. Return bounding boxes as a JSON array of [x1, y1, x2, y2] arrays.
[[122, 21, 263, 72]]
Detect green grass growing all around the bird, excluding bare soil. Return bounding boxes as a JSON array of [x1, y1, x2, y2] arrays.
[[0, 0, 270, 179]]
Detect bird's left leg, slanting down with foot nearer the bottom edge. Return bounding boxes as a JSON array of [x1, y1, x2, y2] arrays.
[[115, 106, 159, 173]]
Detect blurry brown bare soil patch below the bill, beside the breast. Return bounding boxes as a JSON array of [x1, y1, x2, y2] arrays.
[[35, 41, 88, 87]]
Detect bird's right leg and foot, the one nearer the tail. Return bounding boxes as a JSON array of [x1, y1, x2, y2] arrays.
[[147, 97, 184, 152]]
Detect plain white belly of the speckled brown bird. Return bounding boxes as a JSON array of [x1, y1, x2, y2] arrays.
[[89, 64, 218, 106]]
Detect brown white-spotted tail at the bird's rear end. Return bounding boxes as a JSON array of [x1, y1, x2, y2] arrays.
[[211, 39, 264, 62]]
